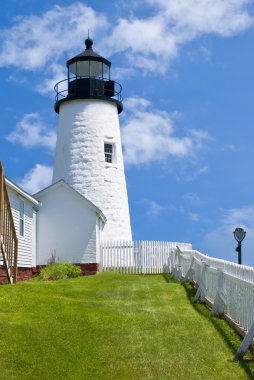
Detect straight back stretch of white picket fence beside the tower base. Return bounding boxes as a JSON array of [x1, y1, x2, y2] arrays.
[[100, 241, 192, 274]]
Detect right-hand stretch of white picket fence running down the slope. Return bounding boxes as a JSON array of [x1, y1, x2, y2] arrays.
[[173, 248, 254, 359]]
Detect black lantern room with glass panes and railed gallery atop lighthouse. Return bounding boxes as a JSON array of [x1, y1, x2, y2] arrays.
[[55, 38, 123, 113]]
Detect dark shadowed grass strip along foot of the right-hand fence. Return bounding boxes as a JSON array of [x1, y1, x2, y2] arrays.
[[183, 279, 254, 380]]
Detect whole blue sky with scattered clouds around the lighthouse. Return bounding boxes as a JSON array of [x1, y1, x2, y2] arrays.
[[0, 0, 254, 265]]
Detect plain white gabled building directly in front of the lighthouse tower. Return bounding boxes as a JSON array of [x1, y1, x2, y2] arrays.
[[34, 180, 106, 269]]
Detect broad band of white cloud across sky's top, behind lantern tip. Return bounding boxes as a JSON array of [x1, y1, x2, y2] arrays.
[[0, 0, 253, 81]]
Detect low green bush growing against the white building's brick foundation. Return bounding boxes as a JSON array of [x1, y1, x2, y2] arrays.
[[39, 262, 81, 281]]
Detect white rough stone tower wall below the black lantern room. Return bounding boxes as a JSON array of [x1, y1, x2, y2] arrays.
[[53, 99, 132, 241]]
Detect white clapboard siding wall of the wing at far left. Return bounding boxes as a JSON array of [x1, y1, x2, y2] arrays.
[[8, 189, 36, 268]]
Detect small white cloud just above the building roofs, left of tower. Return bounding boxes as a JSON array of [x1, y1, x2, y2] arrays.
[[19, 164, 53, 194]]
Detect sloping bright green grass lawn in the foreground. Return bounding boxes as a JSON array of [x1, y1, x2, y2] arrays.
[[0, 273, 254, 380]]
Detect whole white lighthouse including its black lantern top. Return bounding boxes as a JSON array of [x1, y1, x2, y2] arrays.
[[53, 38, 132, 241]]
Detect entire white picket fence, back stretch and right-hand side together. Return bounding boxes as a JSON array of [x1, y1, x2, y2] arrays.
[[100, 241, 254, 359]]
